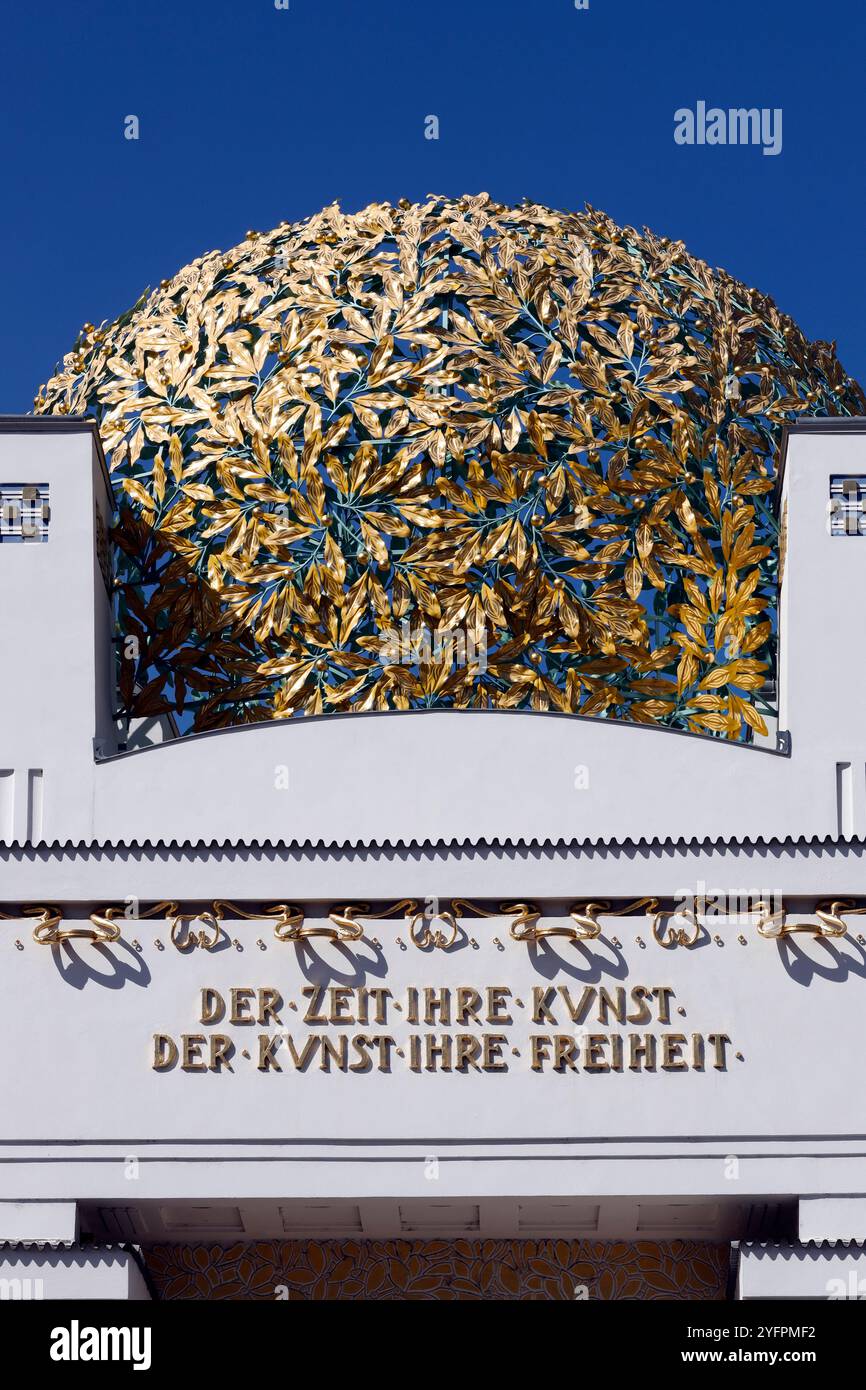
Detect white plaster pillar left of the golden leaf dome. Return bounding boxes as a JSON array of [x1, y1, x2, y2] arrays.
[[0, 424, 114, 841]]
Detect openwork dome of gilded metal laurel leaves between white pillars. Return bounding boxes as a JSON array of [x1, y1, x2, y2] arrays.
[[35, 195, 866, 738]]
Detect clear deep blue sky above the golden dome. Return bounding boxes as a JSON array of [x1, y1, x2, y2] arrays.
[[0, 0, 866, 411]]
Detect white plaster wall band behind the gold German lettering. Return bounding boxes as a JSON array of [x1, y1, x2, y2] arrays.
[[0, 915, 866, 1145]]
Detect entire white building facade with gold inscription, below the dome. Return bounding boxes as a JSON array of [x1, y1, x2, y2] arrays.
[[0, 418, 866, 1297]]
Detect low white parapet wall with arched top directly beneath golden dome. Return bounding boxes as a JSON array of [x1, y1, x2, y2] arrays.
[[89, 710, 806, 845]]
